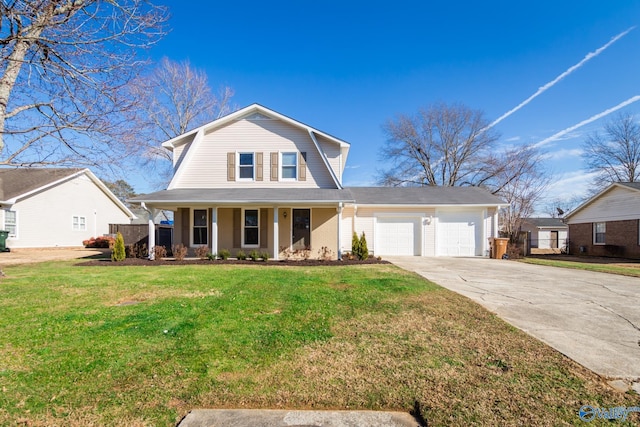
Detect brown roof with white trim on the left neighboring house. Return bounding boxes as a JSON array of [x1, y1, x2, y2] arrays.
[[0, 168, 136, 218]]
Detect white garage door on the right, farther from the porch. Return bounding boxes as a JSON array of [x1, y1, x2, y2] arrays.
[[436, 211, 482, 256]]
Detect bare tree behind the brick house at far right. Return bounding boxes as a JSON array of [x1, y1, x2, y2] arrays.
[[582, 113, 640, 188]]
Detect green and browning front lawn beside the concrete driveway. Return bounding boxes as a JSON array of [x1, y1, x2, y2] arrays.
[[0, 262, 640, 426]]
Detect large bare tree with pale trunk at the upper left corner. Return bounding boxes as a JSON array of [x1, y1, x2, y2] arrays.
[[0, 0, 167, 166]]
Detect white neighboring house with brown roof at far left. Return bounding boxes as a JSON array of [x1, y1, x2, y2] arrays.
[[0, 168, 135, 248]]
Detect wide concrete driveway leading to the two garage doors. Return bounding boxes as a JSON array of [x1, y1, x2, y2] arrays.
[[387, 257, 640, 382]]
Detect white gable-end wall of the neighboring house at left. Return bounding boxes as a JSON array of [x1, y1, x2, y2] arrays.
[[7, 175, 130, 248]]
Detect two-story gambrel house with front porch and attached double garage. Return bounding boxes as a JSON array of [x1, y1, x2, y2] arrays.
[[131, 104, 503, 259]]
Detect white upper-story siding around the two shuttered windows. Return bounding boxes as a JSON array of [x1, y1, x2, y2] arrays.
[[172, 119, 339, 188]]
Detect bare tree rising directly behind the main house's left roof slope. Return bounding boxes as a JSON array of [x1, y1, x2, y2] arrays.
[[129, 58, 235, 185]]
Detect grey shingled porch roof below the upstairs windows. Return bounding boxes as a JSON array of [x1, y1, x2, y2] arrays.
[[129, 188, 354, 205]]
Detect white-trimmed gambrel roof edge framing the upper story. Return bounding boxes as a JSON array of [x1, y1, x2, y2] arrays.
[[162, 104, 350, 189]]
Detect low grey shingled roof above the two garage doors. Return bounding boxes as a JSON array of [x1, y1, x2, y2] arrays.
[[347, 186, 506, 206]]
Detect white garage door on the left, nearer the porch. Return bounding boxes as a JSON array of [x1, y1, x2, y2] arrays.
[[375, 217, 421, 255]]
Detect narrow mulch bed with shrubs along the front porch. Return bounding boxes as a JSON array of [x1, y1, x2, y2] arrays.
[[75, 258, 389, 267]]
